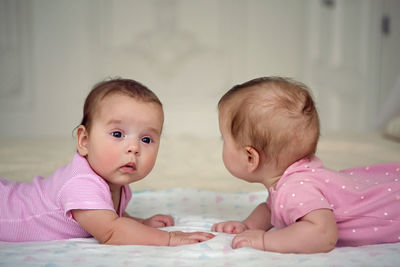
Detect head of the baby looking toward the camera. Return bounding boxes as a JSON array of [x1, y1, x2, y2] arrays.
[[76, 79, 164, 188]]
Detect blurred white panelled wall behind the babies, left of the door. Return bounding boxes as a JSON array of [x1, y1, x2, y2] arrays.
[[0, 0, 305, 136]]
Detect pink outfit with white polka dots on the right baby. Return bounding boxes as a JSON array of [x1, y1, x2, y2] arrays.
[[267, 156, 400, 246]]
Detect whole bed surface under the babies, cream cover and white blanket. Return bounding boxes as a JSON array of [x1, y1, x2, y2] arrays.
[[0, 133, 400, 267]]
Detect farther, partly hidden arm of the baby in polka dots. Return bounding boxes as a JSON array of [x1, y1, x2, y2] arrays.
[[212, 202, 272, 234]]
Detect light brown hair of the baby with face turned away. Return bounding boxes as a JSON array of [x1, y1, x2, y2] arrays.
[[218, 77, 320, 173]]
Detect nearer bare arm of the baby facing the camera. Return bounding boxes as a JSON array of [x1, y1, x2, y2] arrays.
[[71, 210, 214, 246]]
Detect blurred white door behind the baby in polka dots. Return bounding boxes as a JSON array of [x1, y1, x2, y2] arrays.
[[305, 0, 382, 133]]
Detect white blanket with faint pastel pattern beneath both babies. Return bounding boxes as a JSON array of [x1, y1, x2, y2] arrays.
[[0, 189, 400, 267]]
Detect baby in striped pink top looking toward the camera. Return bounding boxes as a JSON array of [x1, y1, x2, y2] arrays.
[[0, 79, 214, 246]]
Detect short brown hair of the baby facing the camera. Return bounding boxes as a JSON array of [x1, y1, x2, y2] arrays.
[[80, 78, 162, 131]]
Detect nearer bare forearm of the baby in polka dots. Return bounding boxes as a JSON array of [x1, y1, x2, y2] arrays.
[[232, 209, 338, 253]]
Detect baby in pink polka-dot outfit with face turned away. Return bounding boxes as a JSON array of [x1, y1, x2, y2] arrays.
[[212, 77, 400, 253]]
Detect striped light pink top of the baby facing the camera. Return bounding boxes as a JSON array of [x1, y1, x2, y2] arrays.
[[0, 153, 132, 241]]
